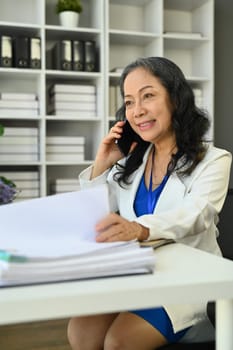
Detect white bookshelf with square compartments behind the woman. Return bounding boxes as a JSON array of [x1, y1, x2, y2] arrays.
[[0, 0, 214, 201]]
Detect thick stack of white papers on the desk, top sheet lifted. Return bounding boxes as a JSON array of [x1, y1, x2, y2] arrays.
[[0, 185, 157, 286]]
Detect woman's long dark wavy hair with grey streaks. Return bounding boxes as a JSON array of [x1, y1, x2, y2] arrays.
[[115, 57, 210, 184]]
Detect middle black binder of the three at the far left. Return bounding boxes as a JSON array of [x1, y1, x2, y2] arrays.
[[13, 36, 29, 68]]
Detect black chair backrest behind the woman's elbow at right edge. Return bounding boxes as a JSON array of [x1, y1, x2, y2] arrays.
[[218, 189, 233, 260]]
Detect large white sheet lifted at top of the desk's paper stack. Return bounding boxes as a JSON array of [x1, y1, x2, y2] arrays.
[[0, 185, 109, 256]]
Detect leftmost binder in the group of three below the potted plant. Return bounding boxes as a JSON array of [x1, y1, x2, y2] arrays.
[[53, 40, 72, 70]]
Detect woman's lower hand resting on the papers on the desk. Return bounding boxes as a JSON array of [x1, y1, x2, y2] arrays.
[[96, 213, 149, 242]]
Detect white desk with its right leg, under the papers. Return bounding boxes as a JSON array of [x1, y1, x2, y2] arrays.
[[0, 244, 233, 350]]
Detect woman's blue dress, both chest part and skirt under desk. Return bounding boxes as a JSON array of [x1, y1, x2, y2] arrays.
[[130, 175, 189, 343]]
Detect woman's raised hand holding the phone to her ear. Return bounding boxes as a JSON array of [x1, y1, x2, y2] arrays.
[[92, 121, 125, 178]]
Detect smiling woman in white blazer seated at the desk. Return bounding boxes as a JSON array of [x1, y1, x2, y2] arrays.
[[68, 57, 231, 350]]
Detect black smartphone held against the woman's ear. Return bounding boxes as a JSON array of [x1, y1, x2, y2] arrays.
[[116, 107, 142, 156]]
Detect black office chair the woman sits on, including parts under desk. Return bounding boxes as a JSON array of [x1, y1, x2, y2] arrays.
[[159, 189, 233, 350]]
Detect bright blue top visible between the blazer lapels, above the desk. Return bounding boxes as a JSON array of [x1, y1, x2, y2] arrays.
[[134, 175, 169, 216]]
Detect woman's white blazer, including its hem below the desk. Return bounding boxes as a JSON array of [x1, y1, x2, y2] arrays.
[[79, 145, 232, 332]]
